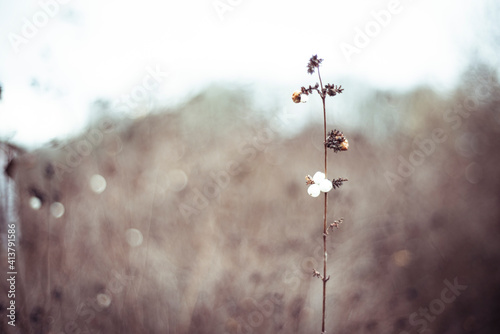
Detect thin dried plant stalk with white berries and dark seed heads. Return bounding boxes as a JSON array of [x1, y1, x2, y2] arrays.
[[292, 55, 349, 334]]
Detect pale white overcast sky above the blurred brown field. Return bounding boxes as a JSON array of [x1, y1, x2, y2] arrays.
[[0, 0, 499, 145]]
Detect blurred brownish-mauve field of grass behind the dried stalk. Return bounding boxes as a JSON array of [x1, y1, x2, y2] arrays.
[[0, 66, 500, 334]]
